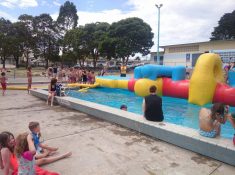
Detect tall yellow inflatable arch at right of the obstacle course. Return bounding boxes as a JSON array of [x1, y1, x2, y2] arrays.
[[188, 53, 224, 105]]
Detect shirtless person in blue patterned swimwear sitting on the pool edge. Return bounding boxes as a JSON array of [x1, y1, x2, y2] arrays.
[[199, 103, 235, 138]]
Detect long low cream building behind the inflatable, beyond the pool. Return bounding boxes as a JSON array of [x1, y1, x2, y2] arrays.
[[151, 40, 235, 67]]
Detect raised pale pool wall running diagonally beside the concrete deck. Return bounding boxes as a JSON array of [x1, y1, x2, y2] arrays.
[[31, 89, 235, 166]]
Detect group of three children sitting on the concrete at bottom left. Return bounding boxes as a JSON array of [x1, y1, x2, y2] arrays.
[[0, 122, 72, 175]]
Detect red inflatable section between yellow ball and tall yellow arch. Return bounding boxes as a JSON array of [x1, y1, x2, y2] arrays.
[[162, 78, 189, 99]]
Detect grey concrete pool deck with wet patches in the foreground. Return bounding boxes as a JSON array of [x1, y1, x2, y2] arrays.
[[0, 91, 235, 175]]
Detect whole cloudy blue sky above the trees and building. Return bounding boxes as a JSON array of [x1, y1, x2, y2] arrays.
[[0, 0, 235, 51]]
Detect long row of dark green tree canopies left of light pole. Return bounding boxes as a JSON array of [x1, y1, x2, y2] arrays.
[[0, 1, 153, 67]]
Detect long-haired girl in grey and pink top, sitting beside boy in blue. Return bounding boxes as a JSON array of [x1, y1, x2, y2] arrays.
[[15, 133, 36, 175]]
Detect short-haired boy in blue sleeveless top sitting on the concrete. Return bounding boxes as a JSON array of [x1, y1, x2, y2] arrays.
[[29, 122, 58, 159]]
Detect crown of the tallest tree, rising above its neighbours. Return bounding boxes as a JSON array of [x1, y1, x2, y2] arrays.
[[56, 1, 78, 36]]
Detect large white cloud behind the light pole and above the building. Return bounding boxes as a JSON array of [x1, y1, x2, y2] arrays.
[[72, 0, 235, 50]]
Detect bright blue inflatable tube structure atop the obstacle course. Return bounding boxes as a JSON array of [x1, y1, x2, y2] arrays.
[[134, 64, 186, 81]]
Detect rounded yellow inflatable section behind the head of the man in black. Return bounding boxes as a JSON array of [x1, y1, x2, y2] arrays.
[[134, 78, 163, 97]]
